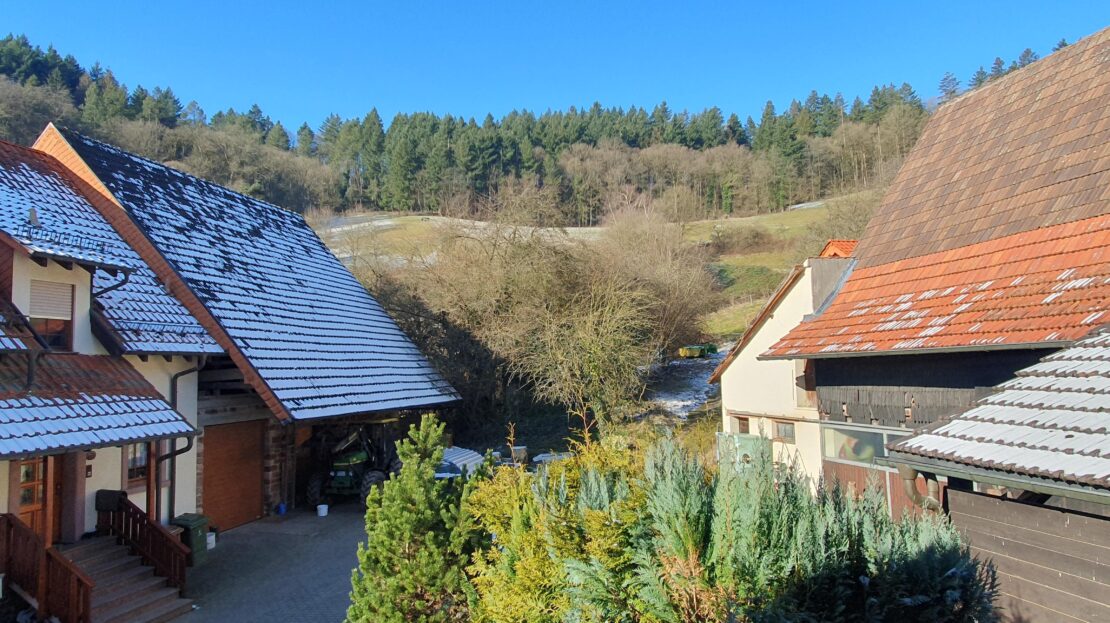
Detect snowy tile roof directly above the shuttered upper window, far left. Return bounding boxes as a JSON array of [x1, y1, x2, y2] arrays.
[[0, 141, 138, 270]]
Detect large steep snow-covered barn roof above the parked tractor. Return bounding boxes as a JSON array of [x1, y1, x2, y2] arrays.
[[61, 130, 457, 419]]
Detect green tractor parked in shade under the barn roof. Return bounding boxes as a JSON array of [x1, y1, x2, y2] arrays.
[[305, 425, 401, 506]]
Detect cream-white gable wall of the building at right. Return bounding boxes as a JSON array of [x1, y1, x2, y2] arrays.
[[720, 262, 821, 485]]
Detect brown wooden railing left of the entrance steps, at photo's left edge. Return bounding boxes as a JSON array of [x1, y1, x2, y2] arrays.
[[0, 513, 93, 623]]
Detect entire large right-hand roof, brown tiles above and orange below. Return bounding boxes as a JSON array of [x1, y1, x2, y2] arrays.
[[764, 29, 1110, 358]]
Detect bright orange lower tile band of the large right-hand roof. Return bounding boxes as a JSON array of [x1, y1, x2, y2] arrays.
[[763, 214, 1110, 358]]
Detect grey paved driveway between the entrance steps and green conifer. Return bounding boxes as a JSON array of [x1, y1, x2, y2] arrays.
[[179, 503, 366, 623]]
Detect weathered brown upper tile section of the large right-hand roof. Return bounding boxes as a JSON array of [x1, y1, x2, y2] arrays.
[[856, 29, 1110, 268]]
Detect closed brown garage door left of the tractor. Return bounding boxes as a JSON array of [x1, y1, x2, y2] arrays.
[[203, 420, 265, 530]]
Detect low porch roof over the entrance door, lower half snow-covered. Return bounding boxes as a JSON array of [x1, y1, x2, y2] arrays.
[[0, 353, 193, 458]]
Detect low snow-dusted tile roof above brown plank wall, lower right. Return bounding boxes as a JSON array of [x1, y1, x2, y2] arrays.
[[889, 330, 1110, 489]]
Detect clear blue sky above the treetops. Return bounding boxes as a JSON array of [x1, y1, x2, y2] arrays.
[[8, 0, 1110, 128]]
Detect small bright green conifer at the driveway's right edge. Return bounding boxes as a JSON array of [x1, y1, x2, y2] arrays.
[[346, 414, 470, 623]]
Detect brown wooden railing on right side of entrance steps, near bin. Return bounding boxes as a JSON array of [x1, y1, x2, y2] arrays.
[[97, 498, 189, 595]]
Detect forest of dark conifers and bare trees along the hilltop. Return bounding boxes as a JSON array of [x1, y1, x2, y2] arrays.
[[0, 34, 1056, 225]]
